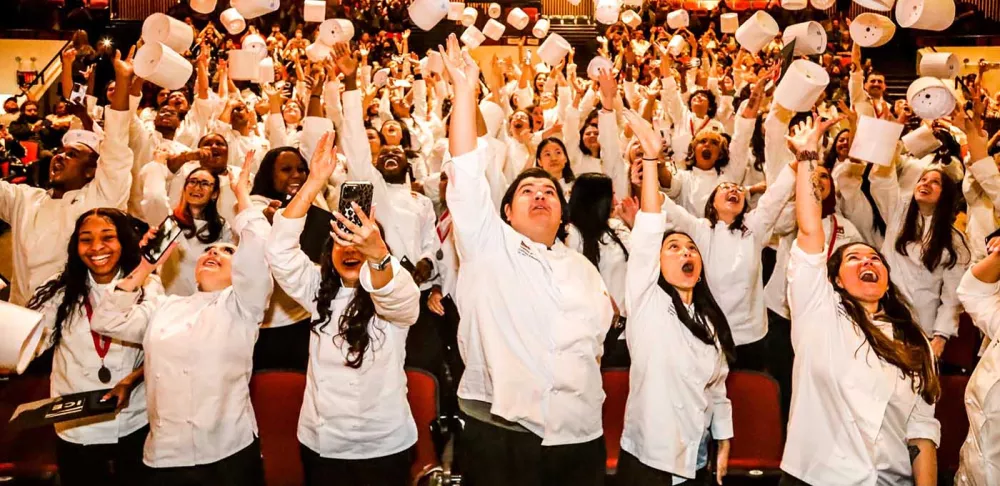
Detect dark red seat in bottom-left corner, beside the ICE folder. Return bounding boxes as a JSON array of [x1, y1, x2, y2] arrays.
[[0, 375, 58, 482]]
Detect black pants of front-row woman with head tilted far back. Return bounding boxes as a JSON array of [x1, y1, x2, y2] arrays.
[[148, 439, 264, 486]]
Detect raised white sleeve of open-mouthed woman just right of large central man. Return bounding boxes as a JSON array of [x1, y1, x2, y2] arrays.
[[625, 211, 666, 316]]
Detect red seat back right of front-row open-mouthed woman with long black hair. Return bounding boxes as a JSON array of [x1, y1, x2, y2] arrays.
[[726, 371, 784, 476]]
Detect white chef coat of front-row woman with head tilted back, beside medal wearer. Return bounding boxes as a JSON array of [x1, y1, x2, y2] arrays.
[[92, 208, 272, 468]]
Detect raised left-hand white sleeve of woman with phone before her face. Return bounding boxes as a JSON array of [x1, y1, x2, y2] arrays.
[[267, 209, 322, 318]]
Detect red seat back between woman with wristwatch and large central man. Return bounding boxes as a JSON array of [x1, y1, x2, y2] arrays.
[[406, 368, 440, 478]]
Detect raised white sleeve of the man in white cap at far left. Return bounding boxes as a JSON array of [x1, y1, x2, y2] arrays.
[[83, 109, 133, 209]]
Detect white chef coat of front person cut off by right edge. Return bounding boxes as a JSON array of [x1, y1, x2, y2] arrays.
[[955, 270, 1000, 486]]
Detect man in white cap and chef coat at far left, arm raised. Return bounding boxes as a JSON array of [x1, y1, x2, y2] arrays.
[[0, 53, 132, 305]]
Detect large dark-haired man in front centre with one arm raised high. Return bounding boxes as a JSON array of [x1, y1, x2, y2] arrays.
[[443, 34, 614, 486]]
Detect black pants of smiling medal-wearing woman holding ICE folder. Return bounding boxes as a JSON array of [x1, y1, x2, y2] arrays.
[[56, 425, 149, 486]]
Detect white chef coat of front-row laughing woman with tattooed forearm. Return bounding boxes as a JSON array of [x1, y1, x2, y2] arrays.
[[781, 240, 941, 486]]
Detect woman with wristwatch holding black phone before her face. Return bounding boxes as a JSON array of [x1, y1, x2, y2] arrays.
[[267, 132, 420, 486]]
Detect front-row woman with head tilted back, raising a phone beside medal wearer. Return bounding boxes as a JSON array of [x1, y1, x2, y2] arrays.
[[91, 154, 272, 486]]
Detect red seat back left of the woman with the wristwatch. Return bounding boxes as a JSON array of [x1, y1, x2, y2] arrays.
[[250, 371, 306, 486]]
